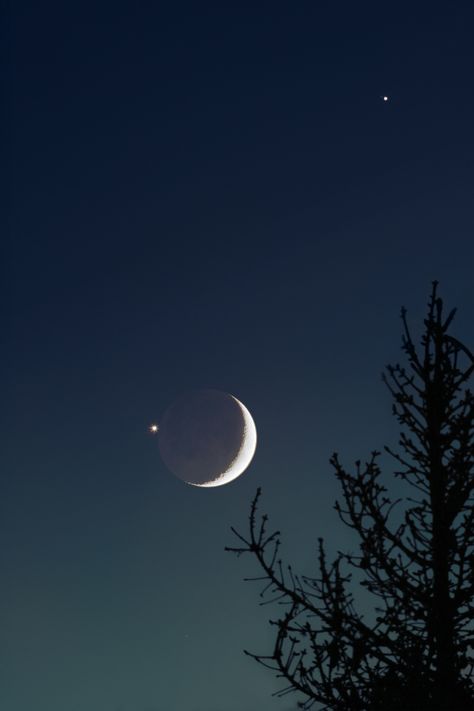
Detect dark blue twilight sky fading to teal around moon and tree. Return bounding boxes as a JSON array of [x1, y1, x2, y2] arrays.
[[5, 5, 474, 711]]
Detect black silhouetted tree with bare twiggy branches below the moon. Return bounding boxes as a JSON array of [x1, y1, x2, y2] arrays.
[[227, 282, 474, 711]]
